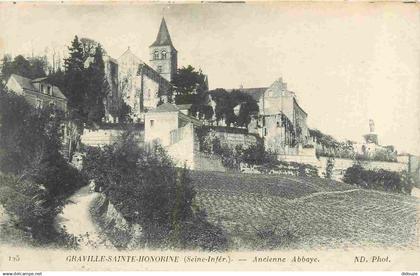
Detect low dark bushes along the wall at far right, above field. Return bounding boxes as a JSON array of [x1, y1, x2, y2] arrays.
[[343, 164, 414, 195]]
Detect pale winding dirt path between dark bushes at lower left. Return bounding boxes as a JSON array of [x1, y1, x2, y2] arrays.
[[56, 186, 112, 248]]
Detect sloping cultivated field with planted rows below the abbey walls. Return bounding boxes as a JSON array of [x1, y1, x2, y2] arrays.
[[191, 171, 419, 249]]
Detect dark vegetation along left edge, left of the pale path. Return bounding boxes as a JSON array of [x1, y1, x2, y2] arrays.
[[0, 89, 86, 244]]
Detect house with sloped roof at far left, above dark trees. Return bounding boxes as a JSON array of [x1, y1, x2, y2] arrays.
[[6, 74, 67, 112]]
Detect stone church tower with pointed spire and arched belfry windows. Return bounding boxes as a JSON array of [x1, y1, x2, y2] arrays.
[[149, 18, 178, 81]]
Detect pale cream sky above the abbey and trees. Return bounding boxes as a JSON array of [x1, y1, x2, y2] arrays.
[[0, 2, 420, 155]]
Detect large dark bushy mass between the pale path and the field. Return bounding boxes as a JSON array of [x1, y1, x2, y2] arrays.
[[84, 132, 224, 250]]
